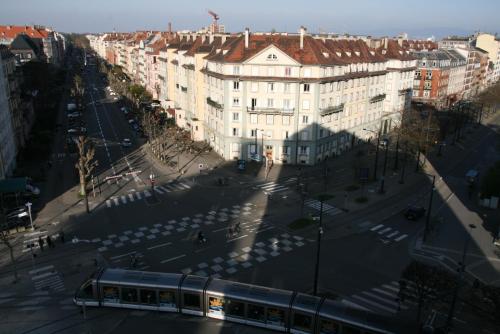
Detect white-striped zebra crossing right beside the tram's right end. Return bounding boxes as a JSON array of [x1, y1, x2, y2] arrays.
[[341, 281, 417, 315]]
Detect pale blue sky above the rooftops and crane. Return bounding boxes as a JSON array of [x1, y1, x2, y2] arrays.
[[0, 0, 500, 38]]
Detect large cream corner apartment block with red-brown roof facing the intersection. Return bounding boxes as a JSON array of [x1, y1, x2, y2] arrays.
[[91, 29, 416, 164]]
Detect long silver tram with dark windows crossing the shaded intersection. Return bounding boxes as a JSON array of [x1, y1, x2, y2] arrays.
[[74, 268, 414, 334]]
